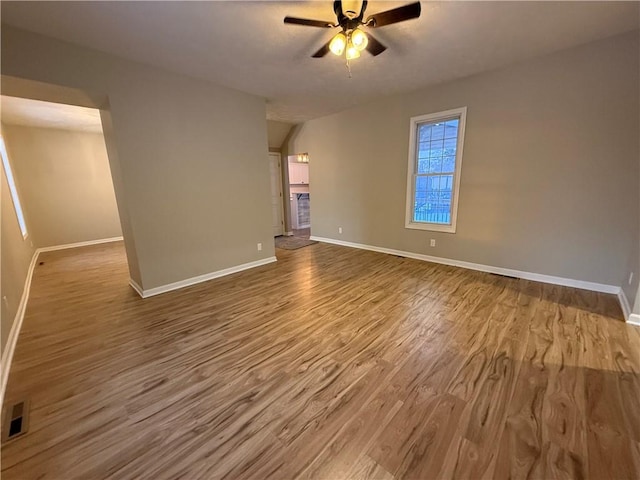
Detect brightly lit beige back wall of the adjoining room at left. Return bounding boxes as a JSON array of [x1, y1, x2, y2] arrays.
[[3, 125, 122, 247]]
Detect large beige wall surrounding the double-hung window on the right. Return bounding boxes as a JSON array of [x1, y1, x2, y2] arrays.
[[286, 32, 640, 303]]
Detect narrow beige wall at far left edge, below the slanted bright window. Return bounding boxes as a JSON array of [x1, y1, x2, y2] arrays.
[[0, 163, 35, 354]]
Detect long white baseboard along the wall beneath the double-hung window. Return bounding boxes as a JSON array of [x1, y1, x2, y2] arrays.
[[311, 236, 620, 294]]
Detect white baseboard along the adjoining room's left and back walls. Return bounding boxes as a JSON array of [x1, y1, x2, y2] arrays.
[[0, 233, 123, 411]]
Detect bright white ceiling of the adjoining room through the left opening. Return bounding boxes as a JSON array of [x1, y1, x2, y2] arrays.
[[0, 95, 102, 133]]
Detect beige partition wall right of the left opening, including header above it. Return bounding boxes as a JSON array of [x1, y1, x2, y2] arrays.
[[2, 25, 274, 289]]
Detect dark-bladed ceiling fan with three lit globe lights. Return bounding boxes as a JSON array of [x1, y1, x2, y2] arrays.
[[284, 0, 421, 60]]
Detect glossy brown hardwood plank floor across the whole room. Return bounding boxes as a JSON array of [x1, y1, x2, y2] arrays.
[[2, 243, 640, 480]]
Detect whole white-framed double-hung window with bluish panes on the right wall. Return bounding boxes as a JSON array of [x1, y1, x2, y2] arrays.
[[405, 107, 467, 233]]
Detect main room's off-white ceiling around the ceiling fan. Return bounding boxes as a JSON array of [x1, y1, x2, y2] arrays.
[[1, 0, 640, 122]]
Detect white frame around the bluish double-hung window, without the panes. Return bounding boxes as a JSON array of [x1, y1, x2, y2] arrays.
[[404, 107, 467, 233]]
